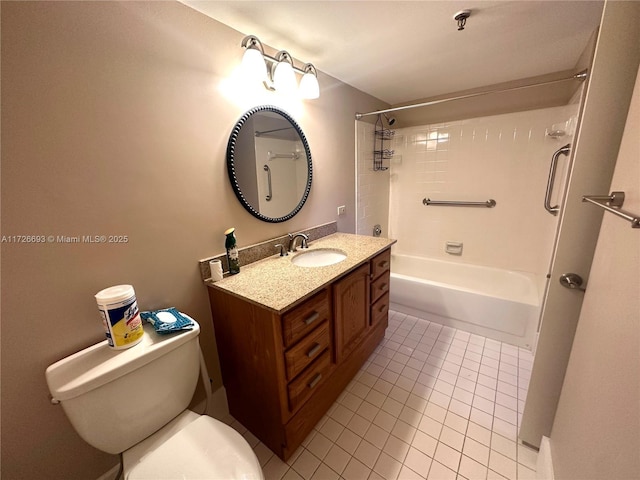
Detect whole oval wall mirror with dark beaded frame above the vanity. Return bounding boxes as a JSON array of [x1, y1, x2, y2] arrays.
[[227, 105, 312, 223]]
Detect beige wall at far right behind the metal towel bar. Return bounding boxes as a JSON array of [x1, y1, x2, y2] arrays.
[[551, 64, 640, 480]]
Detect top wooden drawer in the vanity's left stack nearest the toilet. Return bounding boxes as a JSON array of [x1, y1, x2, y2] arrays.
[[282, 290, 331, 348]]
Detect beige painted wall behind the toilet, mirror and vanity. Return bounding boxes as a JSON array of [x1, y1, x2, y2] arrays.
[[1, 2, 386, 480]]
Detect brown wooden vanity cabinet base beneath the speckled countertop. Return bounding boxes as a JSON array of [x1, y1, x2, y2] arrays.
[[207, 249, 389, 460]]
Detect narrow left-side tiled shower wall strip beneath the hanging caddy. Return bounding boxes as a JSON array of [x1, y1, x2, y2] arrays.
[[356, 122, 392, 237]]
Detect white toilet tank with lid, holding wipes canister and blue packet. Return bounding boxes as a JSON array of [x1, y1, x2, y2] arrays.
[[46, 322, 200, 454]]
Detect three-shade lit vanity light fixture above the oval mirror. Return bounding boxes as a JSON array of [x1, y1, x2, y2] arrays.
[[241, 35, 320, 99]]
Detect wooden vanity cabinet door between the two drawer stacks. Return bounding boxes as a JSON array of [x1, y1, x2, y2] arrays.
[[333, 263, 369, 363]]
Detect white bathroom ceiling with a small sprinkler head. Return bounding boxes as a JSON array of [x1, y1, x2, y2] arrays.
[[181, 0, 602, 105]]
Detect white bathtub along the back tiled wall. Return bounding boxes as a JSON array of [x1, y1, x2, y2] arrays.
[[390, 254, 540, 348]]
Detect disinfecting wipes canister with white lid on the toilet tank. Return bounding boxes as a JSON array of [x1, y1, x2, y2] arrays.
[[96, 285, 144, 350]]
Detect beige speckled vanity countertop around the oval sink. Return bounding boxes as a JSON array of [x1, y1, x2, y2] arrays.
[[206, 233, 396, 313]]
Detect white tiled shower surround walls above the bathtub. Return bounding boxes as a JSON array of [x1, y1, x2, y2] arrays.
[[357, 104, 578, 284]]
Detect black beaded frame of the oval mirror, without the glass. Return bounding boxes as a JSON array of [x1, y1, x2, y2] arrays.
[[227, 105, 313, 223]]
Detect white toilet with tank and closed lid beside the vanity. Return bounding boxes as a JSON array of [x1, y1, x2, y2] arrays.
[[46, 316, 264, 480]]
